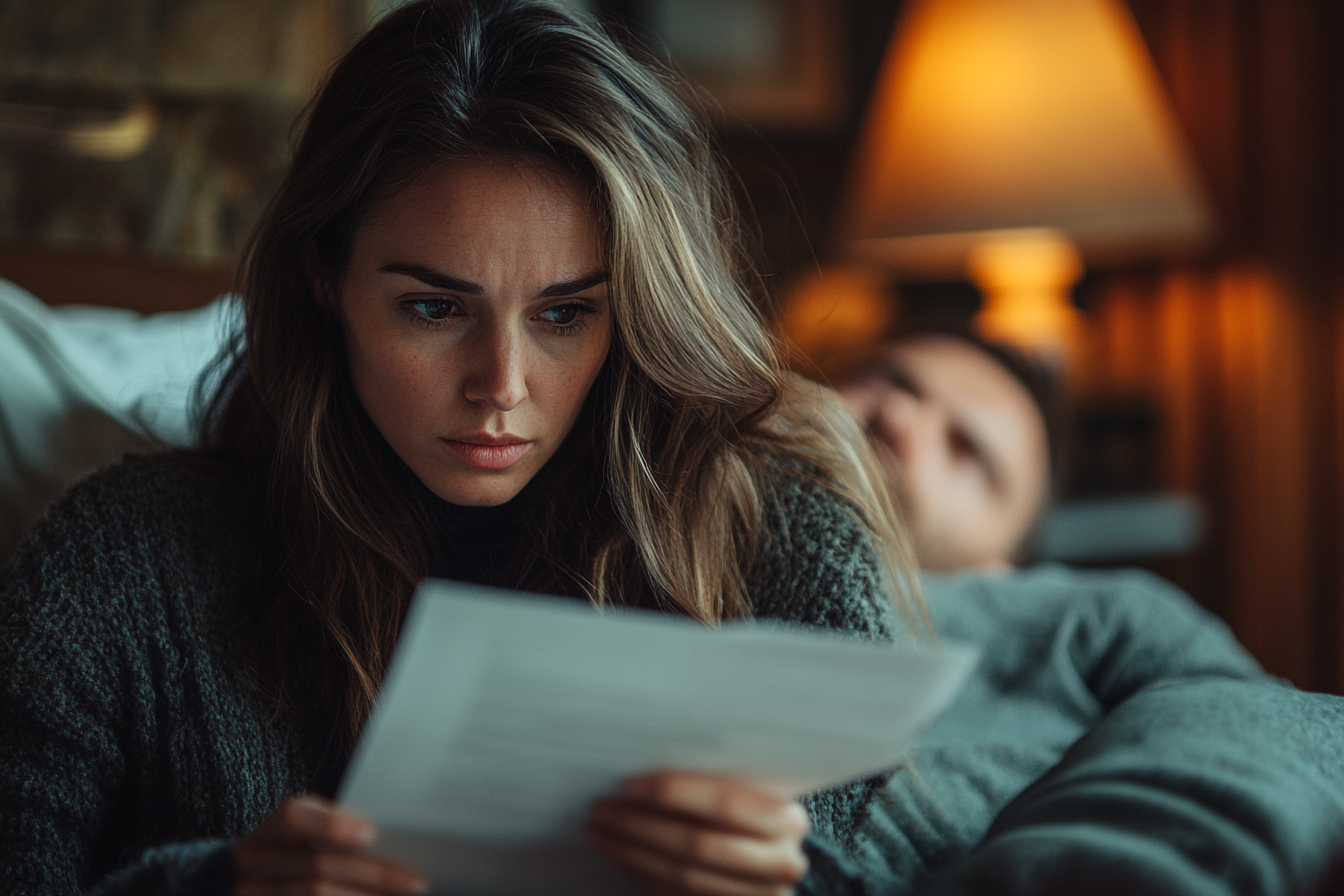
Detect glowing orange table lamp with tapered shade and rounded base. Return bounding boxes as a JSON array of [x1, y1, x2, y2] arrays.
[[843, 0, 1211, 365]]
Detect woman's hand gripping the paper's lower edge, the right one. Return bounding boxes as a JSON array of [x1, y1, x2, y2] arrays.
[[585, 771, 810, 896]]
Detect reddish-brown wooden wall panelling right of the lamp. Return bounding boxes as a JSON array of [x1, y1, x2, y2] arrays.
[[1081, 0, 1344, 693]]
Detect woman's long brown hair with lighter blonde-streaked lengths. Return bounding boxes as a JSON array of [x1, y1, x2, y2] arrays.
[[203, 0, 913, 744]]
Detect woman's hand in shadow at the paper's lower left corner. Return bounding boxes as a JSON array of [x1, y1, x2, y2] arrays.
[[234, 797, 429, 896]]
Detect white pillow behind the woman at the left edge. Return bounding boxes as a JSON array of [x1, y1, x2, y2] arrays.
[[0, 279, 239, 562]]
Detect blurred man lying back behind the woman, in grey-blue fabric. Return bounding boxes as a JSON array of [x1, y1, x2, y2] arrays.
[[809, 334, 1344, 896]]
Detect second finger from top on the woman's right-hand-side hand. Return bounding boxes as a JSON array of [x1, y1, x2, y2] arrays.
[[591, 799, 808, 885]]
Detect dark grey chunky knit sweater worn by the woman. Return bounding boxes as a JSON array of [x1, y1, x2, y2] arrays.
[[0, 457, 891, 895]]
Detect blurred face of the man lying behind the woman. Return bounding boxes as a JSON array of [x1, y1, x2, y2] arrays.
[[840, 336, 1050, 571]]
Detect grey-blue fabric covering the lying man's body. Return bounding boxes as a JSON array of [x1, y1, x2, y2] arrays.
[[804, 567, 1344, 896]]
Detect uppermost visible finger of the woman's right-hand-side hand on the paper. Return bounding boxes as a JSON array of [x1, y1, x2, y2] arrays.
[[625, 771, 812, 841]]
